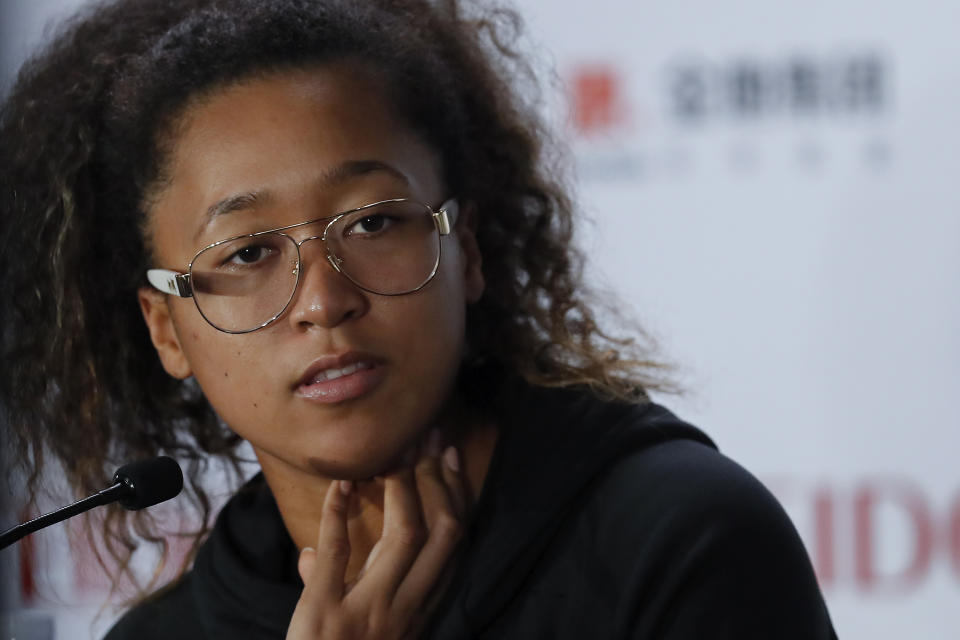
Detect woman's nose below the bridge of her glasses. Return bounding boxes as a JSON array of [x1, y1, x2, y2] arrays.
[[288, 239, 369, 331]]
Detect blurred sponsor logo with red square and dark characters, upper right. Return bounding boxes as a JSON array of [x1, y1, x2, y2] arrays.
[[567, 50, 893, 180]]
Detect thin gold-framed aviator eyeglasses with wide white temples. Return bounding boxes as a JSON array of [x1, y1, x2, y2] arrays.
[[147, 198, 459, 333]]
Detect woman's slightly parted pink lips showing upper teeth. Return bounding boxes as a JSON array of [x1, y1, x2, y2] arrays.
[[294, 351, 386, 403]]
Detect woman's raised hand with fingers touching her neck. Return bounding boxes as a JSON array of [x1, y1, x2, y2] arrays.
[[287, 434, 466, 640]]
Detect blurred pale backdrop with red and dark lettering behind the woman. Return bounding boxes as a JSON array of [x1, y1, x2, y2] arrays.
[[0, 0, 960, 640]]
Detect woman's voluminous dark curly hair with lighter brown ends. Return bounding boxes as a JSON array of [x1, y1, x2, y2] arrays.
[[0, 0, 662, 600]]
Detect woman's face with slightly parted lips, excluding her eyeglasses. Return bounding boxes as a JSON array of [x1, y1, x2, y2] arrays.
[[140, 65, 483, 478]]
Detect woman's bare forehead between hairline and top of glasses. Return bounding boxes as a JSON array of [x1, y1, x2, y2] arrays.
[[149, 65, 442, 257]]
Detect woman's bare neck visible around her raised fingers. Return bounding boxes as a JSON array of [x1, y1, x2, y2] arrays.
[[255, 408, 498, 582]]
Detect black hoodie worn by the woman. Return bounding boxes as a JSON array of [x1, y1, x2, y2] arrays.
[[106, 388, 836, 640]]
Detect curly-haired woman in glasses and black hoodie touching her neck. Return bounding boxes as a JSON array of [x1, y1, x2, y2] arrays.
[[0, 0, 835, 640]]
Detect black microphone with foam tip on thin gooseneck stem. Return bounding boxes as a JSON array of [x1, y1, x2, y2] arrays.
[[0, 456, 183, 549]]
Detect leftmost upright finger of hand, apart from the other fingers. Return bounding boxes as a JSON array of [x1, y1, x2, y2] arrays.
[[301, 480, 352, 602]]
